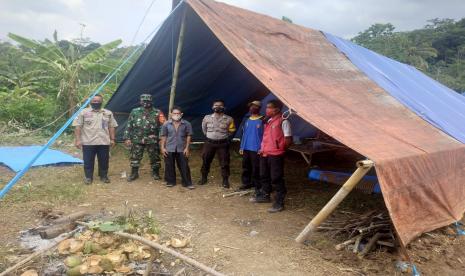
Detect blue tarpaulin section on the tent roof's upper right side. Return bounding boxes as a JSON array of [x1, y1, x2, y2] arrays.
[[324, 33, 465, 143]]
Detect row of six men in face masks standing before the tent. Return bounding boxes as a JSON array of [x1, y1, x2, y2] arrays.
[[73, 94, 292, 213]]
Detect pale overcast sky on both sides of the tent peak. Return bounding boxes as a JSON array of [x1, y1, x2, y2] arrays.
[[0, 0, 465, 45]]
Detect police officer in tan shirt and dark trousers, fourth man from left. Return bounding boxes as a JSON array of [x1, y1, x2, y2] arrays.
[[199, 100, 236, 188]]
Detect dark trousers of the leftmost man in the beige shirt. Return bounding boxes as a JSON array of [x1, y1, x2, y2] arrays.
[[82, 145, 110, 179]]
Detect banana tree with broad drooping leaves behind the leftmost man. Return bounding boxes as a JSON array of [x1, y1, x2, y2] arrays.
[[8, 32, 121, 116]]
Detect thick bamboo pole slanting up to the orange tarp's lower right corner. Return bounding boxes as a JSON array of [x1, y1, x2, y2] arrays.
[[295, 160, 374, 243]]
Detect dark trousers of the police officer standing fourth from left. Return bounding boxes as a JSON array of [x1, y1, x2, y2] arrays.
[[201, 141, 230, 179]]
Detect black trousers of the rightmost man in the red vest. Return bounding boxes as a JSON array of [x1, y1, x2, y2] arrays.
[[260, 154, 287, 204]]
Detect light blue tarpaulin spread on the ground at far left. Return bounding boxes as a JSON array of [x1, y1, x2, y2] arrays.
[[0, 146, 82, 172]]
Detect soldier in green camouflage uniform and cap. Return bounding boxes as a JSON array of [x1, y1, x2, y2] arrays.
[[123, 94, 165, 182]]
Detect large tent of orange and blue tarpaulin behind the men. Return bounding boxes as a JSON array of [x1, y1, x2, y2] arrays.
[[107, 0, 465, 243]]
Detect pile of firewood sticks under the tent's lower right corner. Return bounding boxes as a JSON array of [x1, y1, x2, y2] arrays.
[[318, 211, 396, 258]]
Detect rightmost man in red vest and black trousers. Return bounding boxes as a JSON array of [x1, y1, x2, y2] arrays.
[[251, 100, 292, 213]]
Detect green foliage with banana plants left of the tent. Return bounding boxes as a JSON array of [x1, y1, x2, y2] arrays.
[[0, 32, 144, 135]]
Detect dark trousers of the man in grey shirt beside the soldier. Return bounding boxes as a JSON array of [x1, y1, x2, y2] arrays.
[[165, 152, 192, 187]]
